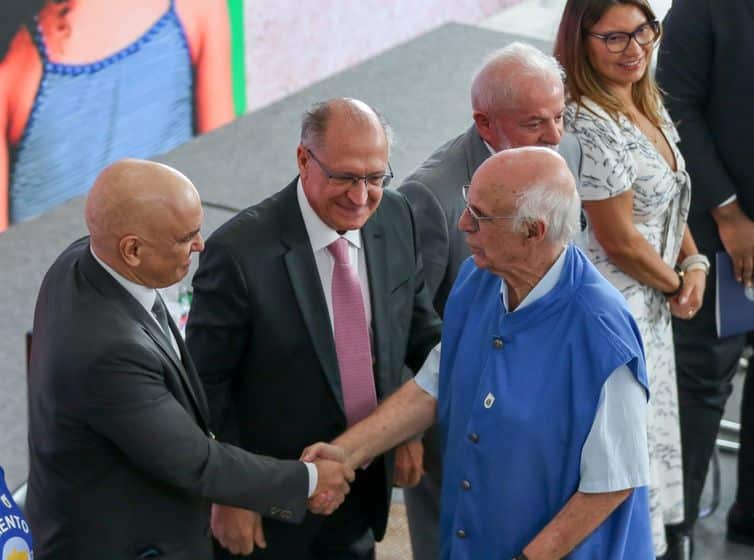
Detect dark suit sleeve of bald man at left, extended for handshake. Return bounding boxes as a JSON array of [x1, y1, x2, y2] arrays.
[[83, 343, 308, 521]]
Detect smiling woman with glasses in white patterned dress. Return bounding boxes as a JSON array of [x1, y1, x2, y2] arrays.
[[555, 0, 709, 556]]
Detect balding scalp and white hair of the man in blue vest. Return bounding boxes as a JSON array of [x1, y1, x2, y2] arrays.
[[472, 147, 581, 246]]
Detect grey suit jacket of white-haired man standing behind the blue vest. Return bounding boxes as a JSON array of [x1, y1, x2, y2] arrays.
[[398, 125, 581, 315]]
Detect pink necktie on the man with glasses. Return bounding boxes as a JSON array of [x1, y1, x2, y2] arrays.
[[327, 237, 377, 426]]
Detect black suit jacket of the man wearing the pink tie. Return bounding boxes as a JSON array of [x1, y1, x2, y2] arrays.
[[187, 180, 440, 539]]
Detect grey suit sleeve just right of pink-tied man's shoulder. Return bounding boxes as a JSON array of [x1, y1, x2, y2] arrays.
[[398, 178, 450, 300]]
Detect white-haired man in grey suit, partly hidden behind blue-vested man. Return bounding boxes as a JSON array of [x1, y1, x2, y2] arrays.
[[397, 42, 581, 560]]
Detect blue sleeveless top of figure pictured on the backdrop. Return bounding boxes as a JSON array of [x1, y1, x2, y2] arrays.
[[9, 0, 194, 223]]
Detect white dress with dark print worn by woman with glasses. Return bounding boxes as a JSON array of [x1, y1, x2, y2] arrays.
[[565, 98, 691, 555]]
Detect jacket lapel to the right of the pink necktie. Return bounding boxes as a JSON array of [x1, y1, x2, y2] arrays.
[[361, 209, 390, 397]]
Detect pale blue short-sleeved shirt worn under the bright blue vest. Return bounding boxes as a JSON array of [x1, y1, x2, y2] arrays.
[[414, 251, 649, 493]]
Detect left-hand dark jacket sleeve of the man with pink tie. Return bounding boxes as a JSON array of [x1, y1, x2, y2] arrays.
[[186, 238, 252, 443]]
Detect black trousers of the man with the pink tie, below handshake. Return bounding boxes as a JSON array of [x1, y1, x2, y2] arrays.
[[215, 461, 385, 560]]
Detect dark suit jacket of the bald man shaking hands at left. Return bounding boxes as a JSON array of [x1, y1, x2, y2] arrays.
[[26, 238, 308, 560]]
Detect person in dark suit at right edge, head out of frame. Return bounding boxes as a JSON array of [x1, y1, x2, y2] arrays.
[[657, 0, 754, 556]]
